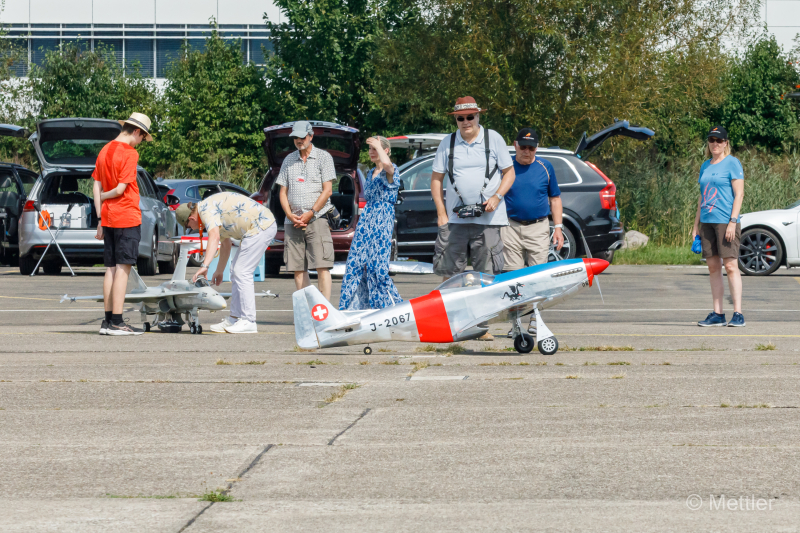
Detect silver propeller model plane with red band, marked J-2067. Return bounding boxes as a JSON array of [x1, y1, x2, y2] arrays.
[[292, 258, 608, 355]]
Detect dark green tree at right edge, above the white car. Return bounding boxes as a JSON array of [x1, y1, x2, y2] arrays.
[[715, 35, 800, 151]]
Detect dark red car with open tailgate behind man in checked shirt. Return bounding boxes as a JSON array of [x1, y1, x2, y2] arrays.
[[251, 121, 366, 276]]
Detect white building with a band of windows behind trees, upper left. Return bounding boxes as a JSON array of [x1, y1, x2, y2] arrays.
[[0, 0, 280, 78]]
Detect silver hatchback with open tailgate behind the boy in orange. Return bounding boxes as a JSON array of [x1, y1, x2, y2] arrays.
[[0, 118, 179, 276]]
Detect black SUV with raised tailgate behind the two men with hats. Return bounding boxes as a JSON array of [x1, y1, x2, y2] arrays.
[[390, 120, 654, 262]]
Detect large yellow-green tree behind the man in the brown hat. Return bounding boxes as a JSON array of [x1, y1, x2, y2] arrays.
[[375, 0, 757, 154]]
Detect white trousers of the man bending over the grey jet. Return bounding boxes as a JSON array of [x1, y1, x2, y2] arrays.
[[231, 224, 278, 322]]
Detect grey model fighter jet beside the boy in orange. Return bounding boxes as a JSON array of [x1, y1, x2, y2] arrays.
[[61, 237, 278, 334]]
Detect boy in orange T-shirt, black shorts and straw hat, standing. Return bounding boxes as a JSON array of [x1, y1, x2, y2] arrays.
[[92, 113, 153, 335]]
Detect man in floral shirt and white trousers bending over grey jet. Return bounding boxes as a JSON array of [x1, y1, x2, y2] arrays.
[[175, 192, 278, 333]]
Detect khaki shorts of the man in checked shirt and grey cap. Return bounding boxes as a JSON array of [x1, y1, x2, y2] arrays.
[[283, 217, 333, 272]]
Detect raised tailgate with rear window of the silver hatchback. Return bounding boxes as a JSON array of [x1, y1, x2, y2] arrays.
[[30, 118, 122, 170]]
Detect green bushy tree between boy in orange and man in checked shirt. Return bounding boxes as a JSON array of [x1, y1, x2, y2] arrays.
[[150, 31, 269, 178]]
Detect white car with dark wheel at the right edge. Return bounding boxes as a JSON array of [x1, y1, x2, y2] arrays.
[[739, 200, 800, 276]]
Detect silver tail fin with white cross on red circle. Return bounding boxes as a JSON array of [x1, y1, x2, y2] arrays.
[[292, 286, 351, 349]]
